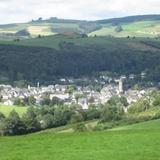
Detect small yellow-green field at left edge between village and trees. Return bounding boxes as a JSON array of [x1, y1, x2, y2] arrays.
[[0, 106, 27, 116]]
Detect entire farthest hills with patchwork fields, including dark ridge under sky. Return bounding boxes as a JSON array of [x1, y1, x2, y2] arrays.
[[0, 15, 160, 39]]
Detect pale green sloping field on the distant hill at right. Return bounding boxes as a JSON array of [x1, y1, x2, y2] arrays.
[[89, 21, 160, 37]]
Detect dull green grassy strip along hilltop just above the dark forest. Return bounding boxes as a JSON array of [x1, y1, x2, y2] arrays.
[[0, 36, 159, 50]]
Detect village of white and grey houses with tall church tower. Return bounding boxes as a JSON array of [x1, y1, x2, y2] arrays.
[[0, 75, 156, 109]]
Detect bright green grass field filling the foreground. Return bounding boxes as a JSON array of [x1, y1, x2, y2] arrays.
[[0, 120, 160, 160]]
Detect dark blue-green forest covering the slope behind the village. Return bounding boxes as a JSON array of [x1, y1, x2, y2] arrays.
[[0, 42, 160, 84]]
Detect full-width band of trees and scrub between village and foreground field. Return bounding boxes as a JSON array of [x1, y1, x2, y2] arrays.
[[0, 92, 160, 135]]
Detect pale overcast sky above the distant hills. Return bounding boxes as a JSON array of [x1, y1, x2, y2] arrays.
[[0, 0, 160, 24]]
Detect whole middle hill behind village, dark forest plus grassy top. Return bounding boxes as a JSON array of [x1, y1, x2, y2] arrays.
[[0, 36, 160, 84]]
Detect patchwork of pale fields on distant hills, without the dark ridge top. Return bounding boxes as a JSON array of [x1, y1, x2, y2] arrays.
[[0, 18, 160, 39]]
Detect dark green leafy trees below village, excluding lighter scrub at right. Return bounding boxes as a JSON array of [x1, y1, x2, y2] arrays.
[[0, 97, 126, 135]]
